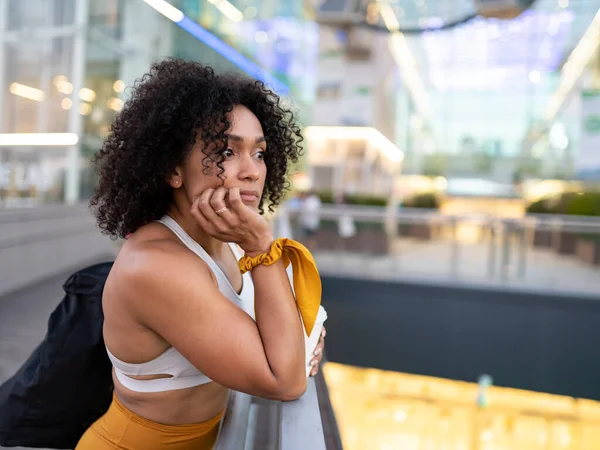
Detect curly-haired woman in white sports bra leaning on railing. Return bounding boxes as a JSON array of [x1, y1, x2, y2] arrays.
[[77, 60, 324, 450]]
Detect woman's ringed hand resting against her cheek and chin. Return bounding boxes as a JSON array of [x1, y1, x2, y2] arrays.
[[191, 187, 273, 256]]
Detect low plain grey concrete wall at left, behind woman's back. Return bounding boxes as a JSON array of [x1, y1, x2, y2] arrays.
[[0, 205, 117, 296]]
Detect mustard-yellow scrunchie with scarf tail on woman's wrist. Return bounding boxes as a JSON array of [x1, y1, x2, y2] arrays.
[[239, 238, 322, 336]]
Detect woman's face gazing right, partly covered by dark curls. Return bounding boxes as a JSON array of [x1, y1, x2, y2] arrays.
[[170, 105, 267, 209]]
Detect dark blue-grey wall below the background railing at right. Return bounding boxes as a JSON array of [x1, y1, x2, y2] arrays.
[[323, 277, 600, 400]]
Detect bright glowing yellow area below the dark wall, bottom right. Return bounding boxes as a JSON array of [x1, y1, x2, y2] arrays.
[[323, 362, 600, 450]]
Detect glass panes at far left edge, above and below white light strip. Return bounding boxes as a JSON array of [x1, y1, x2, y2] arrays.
[[0, 0, 76, 204]]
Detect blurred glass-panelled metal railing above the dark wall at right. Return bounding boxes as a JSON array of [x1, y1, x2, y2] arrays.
[[287, 205, 600, 294]]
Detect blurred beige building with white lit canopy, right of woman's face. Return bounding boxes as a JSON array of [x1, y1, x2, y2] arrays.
[[306, 18, 404, 197]]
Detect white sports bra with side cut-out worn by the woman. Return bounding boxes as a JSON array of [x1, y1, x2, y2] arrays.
[[106, 216, 255, 392]]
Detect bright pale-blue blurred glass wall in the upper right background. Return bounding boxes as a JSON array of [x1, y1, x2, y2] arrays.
[[396, 0, 600, 183]]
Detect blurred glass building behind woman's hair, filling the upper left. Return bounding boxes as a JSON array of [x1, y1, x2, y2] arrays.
[[0, 0, 318, 205]]
